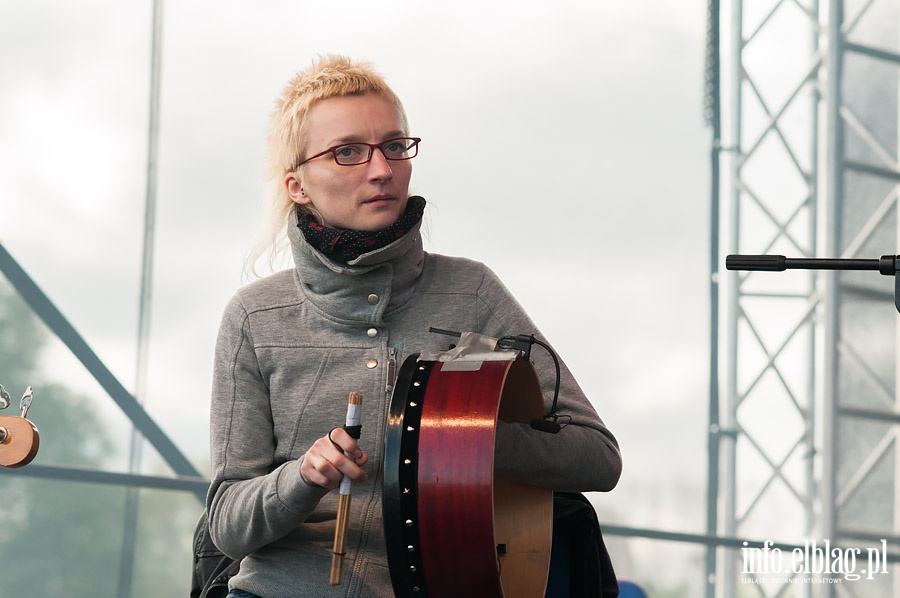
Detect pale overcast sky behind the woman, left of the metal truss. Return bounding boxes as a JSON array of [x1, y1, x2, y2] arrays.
[[0, 0, 710, 592]]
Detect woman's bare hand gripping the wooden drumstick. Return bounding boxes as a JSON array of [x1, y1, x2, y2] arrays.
[[300, 428, 369, 489]]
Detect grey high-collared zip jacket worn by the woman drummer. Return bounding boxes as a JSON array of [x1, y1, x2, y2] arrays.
[[207, 209, 621, 598]]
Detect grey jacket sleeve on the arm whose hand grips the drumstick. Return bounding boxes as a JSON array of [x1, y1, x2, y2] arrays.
[[206, 295, 327, 559]]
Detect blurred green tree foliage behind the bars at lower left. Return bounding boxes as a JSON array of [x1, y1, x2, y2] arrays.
[[0, 278, 202, 598]]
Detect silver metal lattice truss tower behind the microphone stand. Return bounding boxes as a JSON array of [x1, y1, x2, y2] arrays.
[[706, 0, 900, 598]]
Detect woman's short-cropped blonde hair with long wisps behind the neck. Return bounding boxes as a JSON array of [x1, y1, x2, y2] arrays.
[[245, 55, 409, 274]]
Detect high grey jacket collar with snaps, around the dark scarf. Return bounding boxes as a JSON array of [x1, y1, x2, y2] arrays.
[[287, 210, 425, 324]]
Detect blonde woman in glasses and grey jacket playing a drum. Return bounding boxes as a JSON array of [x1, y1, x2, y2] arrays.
[[207, 57, 621, 598]]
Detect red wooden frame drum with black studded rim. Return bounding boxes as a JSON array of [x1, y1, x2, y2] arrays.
[[383, 352, 553, 598]]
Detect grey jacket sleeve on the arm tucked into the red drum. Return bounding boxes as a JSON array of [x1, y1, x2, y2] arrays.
[[478, 268, 622, 492]]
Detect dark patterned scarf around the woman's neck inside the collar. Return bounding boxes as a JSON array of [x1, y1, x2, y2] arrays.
[[297, 195, 425, 264]]
